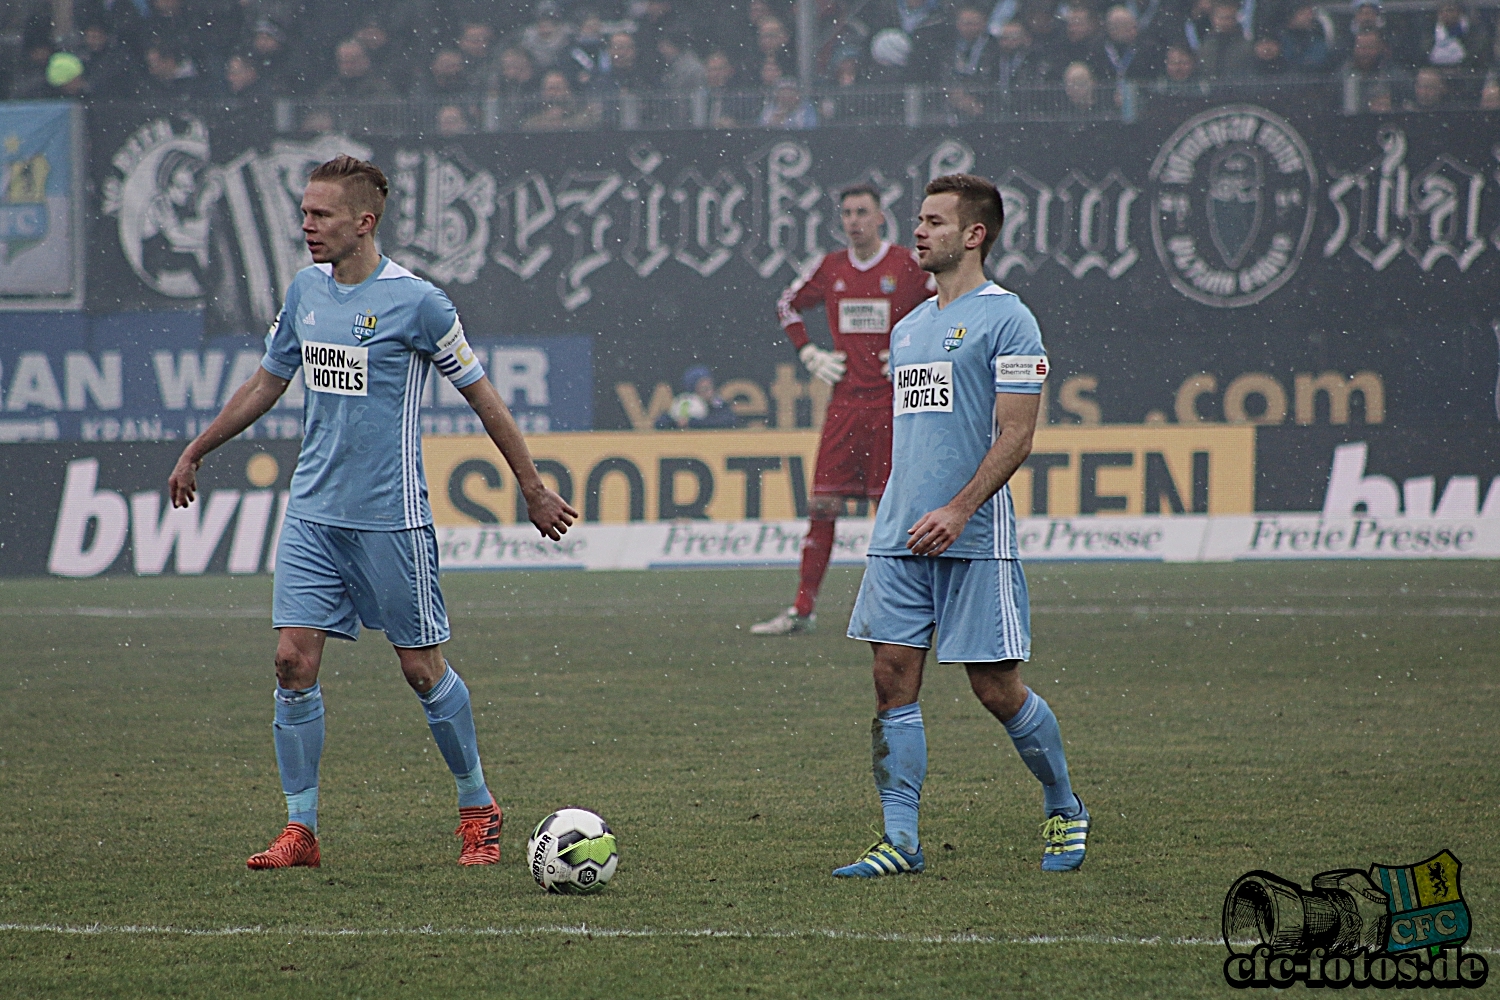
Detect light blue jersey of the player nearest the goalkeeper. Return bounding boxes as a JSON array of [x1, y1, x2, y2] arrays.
[[869, 282, 1047, 559]]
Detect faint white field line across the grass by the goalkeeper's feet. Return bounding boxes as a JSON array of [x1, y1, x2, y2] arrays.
[[0, 604, 1500, 618]]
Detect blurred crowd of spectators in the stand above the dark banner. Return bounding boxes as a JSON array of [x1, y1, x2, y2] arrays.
[[0, 0, 1500, 120]]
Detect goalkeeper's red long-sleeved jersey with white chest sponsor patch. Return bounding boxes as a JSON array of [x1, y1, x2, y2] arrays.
[[776, 243, 938, 408]]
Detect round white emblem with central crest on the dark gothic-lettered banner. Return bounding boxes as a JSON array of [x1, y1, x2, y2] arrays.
[[1151, 105, 1317, 307]]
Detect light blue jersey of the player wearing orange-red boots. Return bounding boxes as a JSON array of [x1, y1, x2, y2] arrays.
[[261, 256, 485, 531]]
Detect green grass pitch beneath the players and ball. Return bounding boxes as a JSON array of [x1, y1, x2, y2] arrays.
[[0, 562, 1500, 999]]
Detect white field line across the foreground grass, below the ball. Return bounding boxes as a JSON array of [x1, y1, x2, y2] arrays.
[[0, 924, 1500, 955]]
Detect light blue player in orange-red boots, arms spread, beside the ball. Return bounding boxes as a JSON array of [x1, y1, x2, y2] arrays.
[[168, 156, 578, 868]]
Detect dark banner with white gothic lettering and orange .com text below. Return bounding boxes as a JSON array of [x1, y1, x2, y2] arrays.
[[89, 105, 1500, 429]]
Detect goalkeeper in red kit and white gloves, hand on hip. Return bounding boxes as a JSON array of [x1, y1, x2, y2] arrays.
[[750, 184, 935, 636]]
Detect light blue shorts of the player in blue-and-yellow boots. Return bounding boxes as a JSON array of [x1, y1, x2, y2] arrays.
[[849, 556, 1031, 663]]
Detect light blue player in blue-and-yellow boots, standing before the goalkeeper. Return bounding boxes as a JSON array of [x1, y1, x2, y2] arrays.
[[834, 174, 1089, 879]]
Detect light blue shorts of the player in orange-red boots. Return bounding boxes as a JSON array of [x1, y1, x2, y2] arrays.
[[272, 517, 450, 649]]
